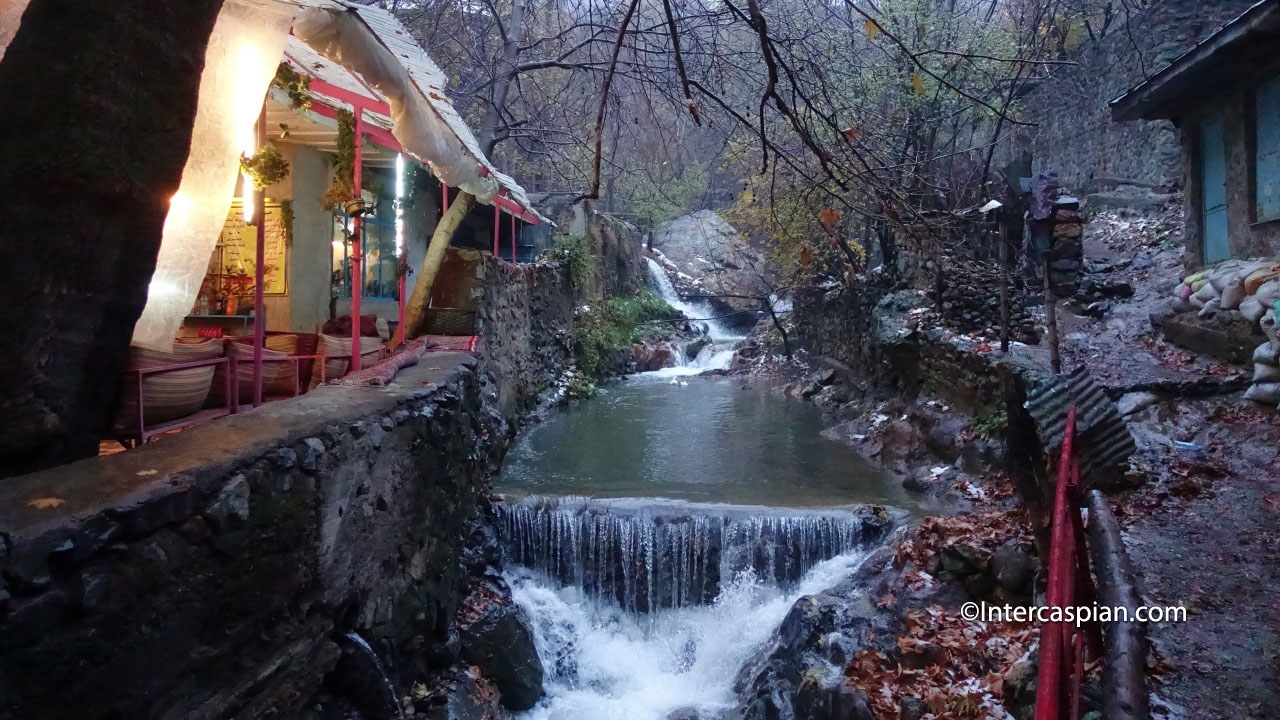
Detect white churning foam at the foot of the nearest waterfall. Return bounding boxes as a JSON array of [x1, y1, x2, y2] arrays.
[[507, 551, 867, 720]]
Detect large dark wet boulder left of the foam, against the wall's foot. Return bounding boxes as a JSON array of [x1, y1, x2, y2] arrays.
[[458, 577, 543, 712]]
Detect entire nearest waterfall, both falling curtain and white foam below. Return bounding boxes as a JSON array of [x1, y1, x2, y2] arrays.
[[497, 497, 892, 720]]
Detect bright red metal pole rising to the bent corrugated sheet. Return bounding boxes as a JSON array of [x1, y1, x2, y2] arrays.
[[1036, 405, 1075, 720]]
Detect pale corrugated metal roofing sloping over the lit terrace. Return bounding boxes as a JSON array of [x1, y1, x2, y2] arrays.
[[340, 0, 550, 223]]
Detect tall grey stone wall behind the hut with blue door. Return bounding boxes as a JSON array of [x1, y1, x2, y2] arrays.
[[1002, 0, 1254, 193]]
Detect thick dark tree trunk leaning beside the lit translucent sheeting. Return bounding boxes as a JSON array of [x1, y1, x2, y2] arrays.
[[0, 0, 223, 477]]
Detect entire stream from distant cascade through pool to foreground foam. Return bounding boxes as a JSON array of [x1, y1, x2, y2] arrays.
[[483, 260, 915, 720]]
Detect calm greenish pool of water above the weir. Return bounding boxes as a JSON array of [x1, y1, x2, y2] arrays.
[[495, 374, 914, 509]]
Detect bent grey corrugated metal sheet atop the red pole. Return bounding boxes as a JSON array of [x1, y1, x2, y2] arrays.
[[1027, 366, 1138, 483]]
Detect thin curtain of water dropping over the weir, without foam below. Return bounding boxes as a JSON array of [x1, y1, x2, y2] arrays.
[[497, 496, 891, 614]]
